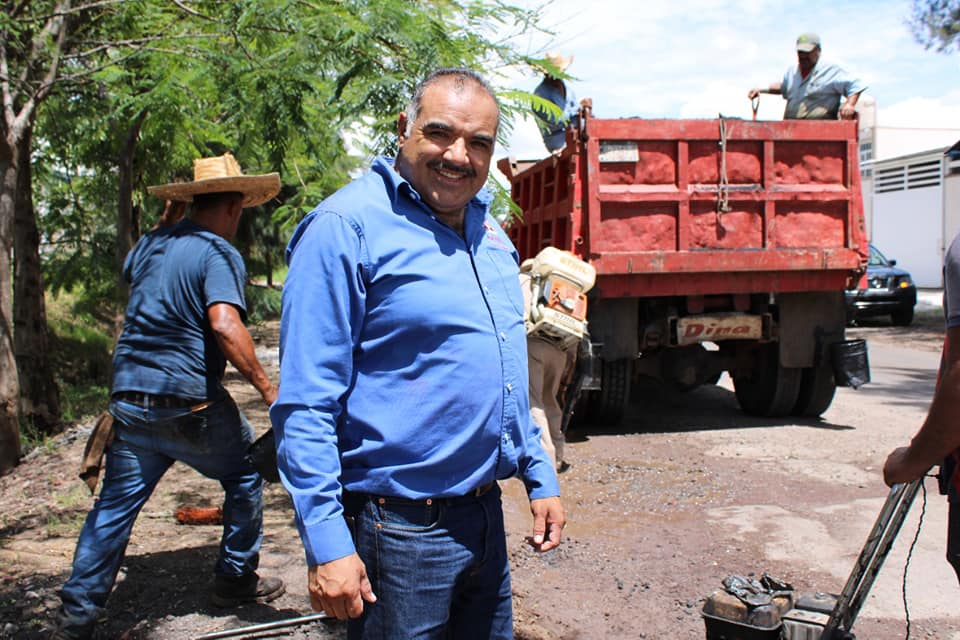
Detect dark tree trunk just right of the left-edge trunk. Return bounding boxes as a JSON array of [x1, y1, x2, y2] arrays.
[[13, 122, 60, 434]]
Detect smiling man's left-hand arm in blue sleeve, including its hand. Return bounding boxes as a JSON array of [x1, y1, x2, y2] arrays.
[[270, 211, 377, 620]]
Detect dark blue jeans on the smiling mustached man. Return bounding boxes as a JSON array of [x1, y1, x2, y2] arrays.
[[344, 487, 513, 640]]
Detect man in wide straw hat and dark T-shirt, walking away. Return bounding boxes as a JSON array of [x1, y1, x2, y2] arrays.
[[52, 153, 284, 640]]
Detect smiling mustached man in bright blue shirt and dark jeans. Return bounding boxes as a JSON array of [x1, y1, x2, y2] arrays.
[[271, 69, 564, 639]]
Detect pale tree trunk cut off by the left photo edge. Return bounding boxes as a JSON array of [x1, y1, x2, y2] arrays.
[[0, 136, 20, 475]]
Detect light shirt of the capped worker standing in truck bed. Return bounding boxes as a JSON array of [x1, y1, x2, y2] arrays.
[[780, 61, 867, 120]]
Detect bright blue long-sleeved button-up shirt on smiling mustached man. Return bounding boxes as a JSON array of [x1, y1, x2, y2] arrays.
[[270, 158, 559, 565]]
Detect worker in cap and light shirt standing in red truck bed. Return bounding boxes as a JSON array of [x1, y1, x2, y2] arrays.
[[747, 33, 866, 120]]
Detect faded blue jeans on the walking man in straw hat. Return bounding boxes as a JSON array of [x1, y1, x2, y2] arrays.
[[60, 396, 263, 629]]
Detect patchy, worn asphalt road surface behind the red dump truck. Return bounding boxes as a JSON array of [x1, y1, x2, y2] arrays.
[[505, 326, 960, 640]]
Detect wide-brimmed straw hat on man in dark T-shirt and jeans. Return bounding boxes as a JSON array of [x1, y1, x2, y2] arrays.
[[147, 153, 280, 207]]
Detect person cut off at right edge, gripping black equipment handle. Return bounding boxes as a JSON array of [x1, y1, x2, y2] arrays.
[[883, 229, 960, 581]]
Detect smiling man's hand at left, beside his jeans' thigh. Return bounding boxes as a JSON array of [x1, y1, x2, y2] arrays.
[[307, 553, 377, 620]]
